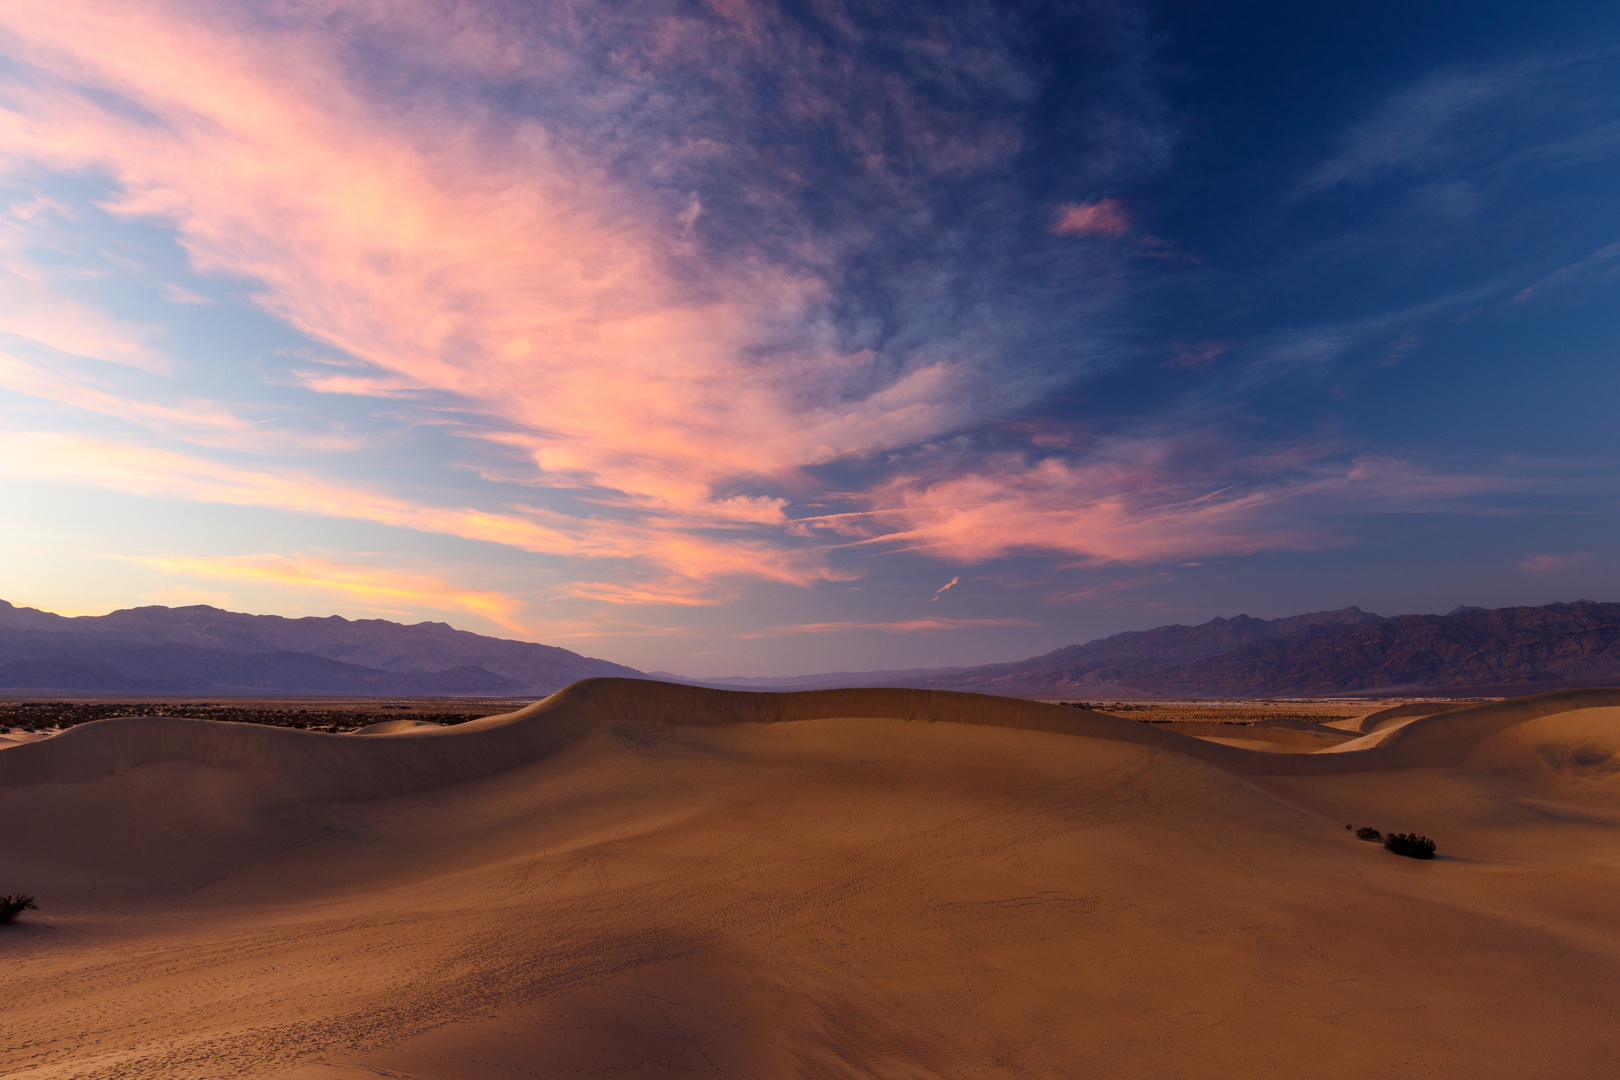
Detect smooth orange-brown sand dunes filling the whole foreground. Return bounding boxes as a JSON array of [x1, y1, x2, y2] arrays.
[[0, 680, 1620, 1080]]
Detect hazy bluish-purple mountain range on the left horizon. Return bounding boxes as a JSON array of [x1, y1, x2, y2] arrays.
[[0, 601, 642, 696]]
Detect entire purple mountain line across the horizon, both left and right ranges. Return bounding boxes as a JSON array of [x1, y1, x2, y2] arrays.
[[0, 601, 1620, 699]]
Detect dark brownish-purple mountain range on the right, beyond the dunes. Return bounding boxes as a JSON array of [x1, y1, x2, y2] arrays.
[[696, 601, 1620, 699]]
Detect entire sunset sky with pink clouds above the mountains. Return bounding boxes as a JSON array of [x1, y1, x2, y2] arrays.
[[0, 0, 1620, 675]]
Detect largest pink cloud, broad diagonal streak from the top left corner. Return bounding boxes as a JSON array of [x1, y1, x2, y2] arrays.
[[0, 0, 970, 547]]
